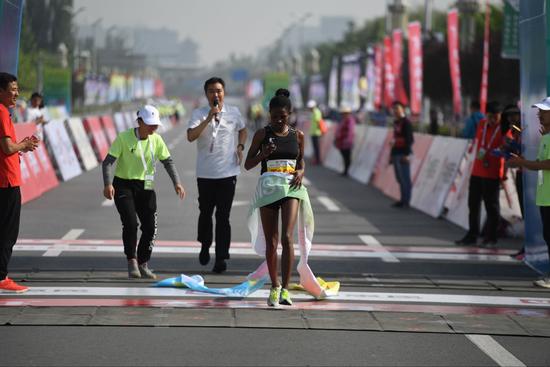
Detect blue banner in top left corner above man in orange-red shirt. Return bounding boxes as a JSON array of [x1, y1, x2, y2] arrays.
[[0, 0, 23, 75]]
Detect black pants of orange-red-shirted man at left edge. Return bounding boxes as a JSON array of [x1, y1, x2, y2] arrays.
[[0, 186, 21, 280]]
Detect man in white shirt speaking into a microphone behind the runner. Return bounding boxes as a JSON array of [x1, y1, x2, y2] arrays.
[[187, 77, 246, 273]]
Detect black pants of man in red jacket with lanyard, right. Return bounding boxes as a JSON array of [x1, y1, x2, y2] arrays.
[[468, 176, 500, 241]]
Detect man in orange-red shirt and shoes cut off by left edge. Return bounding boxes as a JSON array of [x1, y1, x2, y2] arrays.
[[0, 72, 38, 292]]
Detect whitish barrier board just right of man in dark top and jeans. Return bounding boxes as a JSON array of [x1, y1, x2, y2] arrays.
[[411, 136, 468, 218]]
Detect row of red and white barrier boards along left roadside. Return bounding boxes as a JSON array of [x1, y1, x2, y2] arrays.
[[15, 107, 181, 203]]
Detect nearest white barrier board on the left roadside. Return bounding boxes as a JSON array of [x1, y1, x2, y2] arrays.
[[44, 120, 82, 181]]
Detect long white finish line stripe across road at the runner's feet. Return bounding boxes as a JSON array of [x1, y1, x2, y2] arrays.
[[0, 287, 550, 311]]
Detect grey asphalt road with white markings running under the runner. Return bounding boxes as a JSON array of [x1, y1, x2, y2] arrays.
[[0, 107, 550, 366]]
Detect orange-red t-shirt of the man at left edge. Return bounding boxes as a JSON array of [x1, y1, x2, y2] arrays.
[[0, 104, 21, 188]]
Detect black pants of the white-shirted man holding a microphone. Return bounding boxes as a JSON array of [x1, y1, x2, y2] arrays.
[[197, 176, 237, 260]]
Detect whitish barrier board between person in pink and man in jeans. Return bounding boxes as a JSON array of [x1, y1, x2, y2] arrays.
[[350, 126, 388, 184]]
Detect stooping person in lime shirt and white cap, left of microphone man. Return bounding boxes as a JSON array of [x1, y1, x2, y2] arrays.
[[102, 105, 185, 279]]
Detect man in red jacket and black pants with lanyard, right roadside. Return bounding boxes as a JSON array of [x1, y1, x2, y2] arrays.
[[456, 102, 505, 247]]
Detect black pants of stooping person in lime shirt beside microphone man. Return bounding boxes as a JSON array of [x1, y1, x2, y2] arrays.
[[113, 177, 157, 264]]
